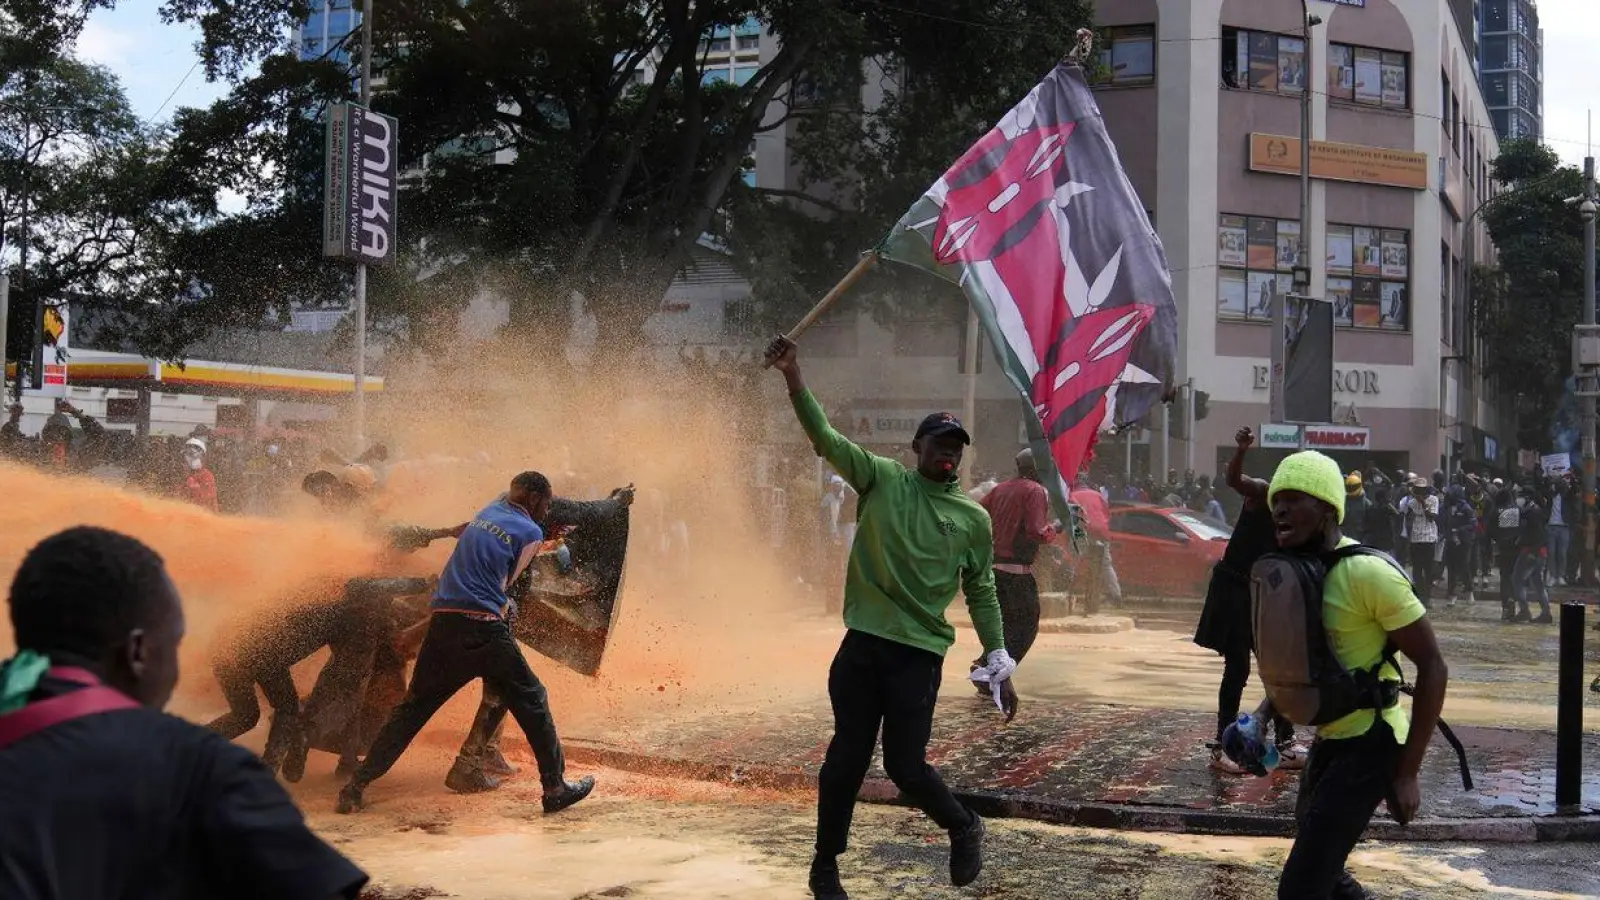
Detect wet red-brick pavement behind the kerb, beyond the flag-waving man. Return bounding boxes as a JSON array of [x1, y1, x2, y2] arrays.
[[566, 602, 1600, 839]]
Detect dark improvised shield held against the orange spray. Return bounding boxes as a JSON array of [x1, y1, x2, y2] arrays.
[[507, 500, 629, 676]]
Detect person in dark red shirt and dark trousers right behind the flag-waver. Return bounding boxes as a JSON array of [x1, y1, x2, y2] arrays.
[[973, 448, 1056, 672]]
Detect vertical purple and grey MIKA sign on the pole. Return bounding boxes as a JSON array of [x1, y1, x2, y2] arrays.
[[322, 102, 400, 266]]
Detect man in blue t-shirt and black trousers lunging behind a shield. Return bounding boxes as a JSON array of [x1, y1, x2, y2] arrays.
[[338, 472, 595, 814]]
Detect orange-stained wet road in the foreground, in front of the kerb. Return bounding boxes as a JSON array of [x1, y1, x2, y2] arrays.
[[298, 761, 1600, 900]]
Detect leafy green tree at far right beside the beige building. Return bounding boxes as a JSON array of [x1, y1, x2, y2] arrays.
[[1472, 138, 1584, 447]]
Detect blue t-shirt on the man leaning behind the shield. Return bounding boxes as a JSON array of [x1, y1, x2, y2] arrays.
[[432, 500, 544, 615]]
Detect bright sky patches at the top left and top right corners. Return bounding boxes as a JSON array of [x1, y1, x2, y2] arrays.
[[68, 0, 1600, 165]]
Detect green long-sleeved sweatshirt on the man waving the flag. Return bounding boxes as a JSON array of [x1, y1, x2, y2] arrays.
[[790, 391, 1005, 657]]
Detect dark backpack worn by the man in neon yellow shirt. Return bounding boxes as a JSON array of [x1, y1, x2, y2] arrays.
[[1250, 544, 1472, 790]]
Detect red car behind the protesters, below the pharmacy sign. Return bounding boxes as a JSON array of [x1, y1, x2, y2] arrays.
[[1110, 506, 1234, 597]]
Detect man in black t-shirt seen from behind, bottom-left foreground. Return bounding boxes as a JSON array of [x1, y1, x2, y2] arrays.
[[0, 528, 366, 900]]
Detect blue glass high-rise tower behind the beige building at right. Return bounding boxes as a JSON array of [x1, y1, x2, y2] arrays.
[[1477, 0, 1544, 139]]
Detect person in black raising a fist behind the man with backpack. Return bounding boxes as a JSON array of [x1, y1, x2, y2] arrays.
[[1194, 428, 1306, 775]]
